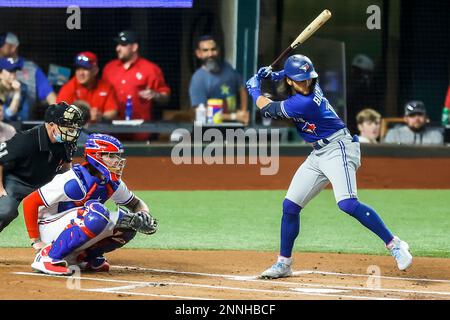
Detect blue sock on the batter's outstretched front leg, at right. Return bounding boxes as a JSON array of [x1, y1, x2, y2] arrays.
[[338, 199, 394, 244]]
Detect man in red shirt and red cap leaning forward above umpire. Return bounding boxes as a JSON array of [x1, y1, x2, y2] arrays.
[[56, 51, 118, 122]]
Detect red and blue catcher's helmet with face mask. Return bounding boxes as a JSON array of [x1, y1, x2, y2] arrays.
[[84, 133, 126, 182]]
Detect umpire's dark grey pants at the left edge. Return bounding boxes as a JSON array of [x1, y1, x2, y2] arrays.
[[0, 174, 36, 232]]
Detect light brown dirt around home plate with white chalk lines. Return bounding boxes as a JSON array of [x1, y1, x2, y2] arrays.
[[0, 249, 450, 300]]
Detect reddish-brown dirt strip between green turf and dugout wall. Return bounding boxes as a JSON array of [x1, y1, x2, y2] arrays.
[[113, 157, 450, 190]]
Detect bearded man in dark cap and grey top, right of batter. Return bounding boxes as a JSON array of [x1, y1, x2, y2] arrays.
[[384, 101, 444, 145]]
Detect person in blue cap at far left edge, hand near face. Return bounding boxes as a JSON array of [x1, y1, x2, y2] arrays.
[[0, 58, 30, 122]]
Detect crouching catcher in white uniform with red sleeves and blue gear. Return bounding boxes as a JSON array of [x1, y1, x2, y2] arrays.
[[23, 134, 157, 275]]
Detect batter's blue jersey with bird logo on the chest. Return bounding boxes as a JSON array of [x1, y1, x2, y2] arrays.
[[281, 83, 345, 142]]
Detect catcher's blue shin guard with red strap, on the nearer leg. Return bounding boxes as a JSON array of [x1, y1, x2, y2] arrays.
[[48, 201, 109, 259]]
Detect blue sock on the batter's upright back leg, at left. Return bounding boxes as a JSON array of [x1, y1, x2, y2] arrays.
[[280, 199, 302, 258]]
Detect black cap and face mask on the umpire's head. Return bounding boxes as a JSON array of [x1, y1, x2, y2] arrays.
[[44, 101, 85, 143]]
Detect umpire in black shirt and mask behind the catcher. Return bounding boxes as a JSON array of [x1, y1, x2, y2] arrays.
[[0, 102, 84, 232]]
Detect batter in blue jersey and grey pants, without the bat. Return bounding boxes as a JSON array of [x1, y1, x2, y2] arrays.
[[246, 54, 412, 279]]
